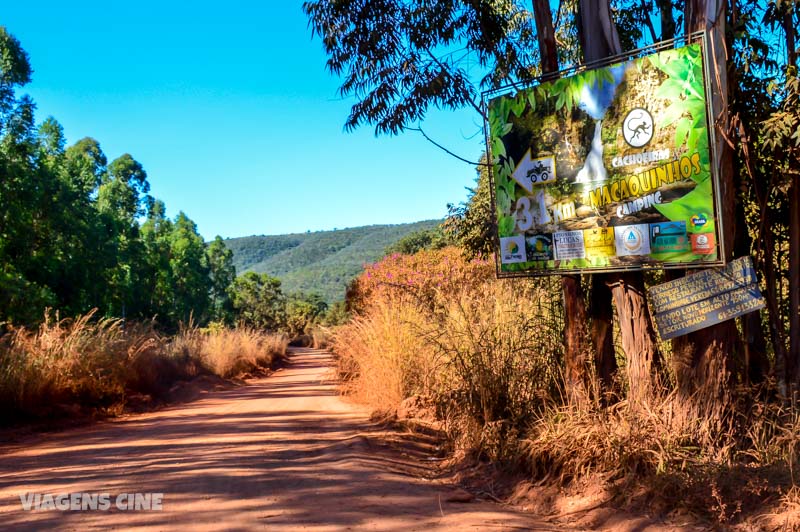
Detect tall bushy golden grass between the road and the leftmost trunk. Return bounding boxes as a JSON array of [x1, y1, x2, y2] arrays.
[[334, 248, 561, 457]]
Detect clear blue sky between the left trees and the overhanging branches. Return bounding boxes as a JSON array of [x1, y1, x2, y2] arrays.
[[0, 1, 483, 239]]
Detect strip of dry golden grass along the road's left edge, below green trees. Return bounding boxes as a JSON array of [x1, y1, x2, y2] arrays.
[[0, 312, 286, 422]]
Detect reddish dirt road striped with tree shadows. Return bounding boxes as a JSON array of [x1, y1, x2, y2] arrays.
[[0, 349, 554, 531]]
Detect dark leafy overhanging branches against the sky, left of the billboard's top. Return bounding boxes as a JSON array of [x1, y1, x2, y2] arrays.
[[303, 0, 537, 135]]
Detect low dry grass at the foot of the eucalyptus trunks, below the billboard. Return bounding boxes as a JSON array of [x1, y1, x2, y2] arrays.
[[520, 386, 800, 529]]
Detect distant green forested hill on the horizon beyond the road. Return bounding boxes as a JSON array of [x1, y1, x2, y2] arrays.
[[225, 220, 441, 303]]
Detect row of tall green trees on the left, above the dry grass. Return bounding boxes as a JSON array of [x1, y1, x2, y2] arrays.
[[0, 27, 222, 328]]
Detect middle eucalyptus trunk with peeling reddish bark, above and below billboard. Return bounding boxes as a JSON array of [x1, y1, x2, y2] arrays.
[[578, 0, 660, 403]]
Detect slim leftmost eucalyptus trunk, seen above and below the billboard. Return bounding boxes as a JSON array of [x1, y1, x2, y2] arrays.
[[533, 0, 589, 403]]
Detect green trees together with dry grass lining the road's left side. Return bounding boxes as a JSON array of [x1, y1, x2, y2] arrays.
[[0, 26, 344, 423]]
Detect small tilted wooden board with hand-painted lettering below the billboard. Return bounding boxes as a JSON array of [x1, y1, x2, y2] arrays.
[[648, 257, 764, 340]]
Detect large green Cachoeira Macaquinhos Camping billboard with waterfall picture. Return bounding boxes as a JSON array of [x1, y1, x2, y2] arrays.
[[487, 43, 722, 276]]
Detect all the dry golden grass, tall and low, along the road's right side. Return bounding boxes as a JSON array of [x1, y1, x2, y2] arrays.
[[334, 250, 800, 523]]
